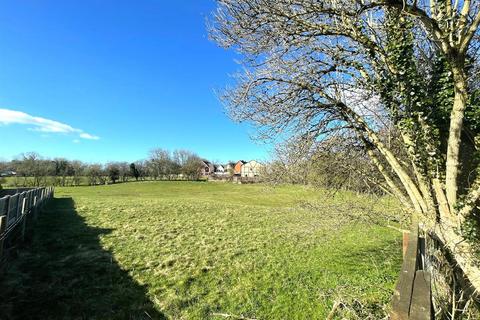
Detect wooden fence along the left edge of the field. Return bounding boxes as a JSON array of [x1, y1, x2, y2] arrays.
[[0, 187, 54, 262]]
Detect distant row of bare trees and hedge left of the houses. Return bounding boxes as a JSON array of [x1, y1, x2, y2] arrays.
[[0, 148, 203, 187]]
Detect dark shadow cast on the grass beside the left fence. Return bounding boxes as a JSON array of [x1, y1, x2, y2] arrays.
[[0, 198, 166, 319]]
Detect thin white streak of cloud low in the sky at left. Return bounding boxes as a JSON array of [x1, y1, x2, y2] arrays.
[[0, 108, 100, 140]]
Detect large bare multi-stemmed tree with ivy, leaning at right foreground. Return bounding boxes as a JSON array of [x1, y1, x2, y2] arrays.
[[211, 0, 480, 298]]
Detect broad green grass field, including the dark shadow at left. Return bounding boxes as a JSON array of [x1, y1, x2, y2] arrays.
[[0, 182, 401, 319]]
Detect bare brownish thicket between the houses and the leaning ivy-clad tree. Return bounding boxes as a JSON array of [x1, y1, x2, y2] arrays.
[[262, 137, 390, 195]]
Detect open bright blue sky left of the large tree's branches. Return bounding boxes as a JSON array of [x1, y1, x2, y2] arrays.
[[0, 0, 268, 162]]
